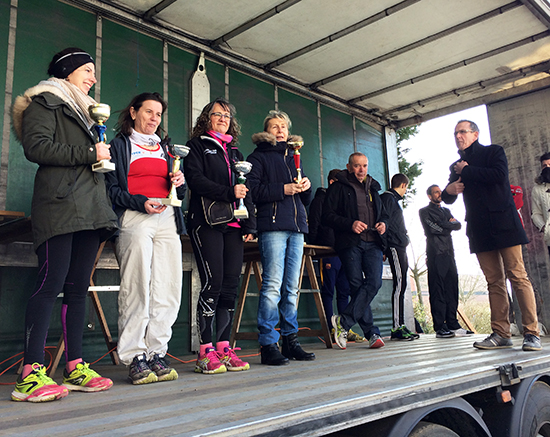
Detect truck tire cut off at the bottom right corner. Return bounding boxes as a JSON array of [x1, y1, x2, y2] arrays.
[[521, 381, 550, 437]]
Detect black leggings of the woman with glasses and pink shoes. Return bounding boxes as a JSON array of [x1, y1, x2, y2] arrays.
[[190, 226, 243, 344]]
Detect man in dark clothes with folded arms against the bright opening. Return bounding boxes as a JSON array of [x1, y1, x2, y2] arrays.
[[418, 185, 473, 338]]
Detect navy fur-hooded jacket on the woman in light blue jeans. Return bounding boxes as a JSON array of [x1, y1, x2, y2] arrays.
[[247, 132, 311, 234]]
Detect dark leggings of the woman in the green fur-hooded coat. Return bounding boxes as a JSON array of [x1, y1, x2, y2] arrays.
[[24, 231, 100, 364]]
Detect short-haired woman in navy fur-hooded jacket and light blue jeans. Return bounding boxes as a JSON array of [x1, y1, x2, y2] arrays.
[[247, 111, 315, 365]]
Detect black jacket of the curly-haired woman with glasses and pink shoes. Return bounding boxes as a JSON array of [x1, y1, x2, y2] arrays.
[[183, 134, 256, 234]]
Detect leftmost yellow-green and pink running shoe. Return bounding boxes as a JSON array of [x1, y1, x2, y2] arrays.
[[11, 363, 69, 402]]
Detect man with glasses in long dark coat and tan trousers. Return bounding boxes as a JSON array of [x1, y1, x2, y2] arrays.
[[441, 120, 542, 351]]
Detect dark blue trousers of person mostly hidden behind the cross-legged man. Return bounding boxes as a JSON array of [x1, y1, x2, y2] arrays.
[[321, 256, 350, 329]]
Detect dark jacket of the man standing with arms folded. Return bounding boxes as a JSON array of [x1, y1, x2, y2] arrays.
[[418, 202, 462, 260]]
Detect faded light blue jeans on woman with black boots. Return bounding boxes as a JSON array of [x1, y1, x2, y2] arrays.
[[258, 231, 304, 346]]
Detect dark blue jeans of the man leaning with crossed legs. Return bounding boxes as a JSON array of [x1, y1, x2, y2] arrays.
[[338, 240, 382, 338]]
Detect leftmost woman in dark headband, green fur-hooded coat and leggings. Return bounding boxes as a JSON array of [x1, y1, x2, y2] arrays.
[[8, 48, 118, 402]]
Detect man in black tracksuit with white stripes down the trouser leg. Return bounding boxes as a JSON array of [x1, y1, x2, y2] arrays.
[[380, 173, 418, 341]]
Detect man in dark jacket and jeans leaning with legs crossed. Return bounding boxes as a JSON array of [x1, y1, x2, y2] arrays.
[[322, 152, 388, 349]]
